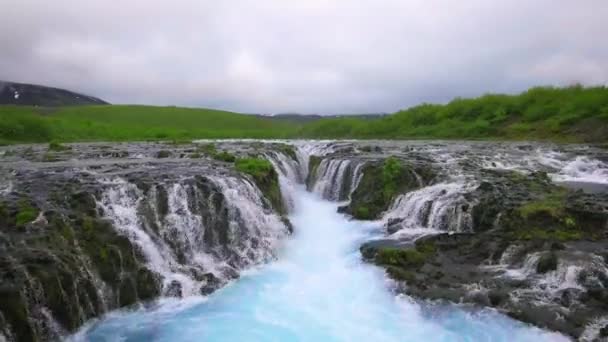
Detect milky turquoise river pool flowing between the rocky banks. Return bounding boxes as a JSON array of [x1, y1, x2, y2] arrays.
[[72, 189, 566, 341]]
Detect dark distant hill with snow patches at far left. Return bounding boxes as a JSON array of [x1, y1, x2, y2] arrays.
[[0, 81, 108, 107]]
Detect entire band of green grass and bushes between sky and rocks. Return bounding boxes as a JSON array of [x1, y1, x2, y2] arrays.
[[0, 86, 608, 143]]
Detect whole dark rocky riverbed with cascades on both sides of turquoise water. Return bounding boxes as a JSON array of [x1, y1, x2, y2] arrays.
[[0, 141, 608, 341]]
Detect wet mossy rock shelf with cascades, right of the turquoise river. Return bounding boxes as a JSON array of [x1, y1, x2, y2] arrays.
[[309, 142, 608, 341]]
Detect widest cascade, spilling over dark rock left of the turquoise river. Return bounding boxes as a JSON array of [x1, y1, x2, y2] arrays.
[[98, 176, 288, 296]]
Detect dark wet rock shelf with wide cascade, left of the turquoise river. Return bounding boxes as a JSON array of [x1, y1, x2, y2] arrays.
[[0, 142, 291, 341]]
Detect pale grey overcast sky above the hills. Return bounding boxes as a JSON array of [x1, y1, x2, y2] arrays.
[[0, 0, 608, 113]]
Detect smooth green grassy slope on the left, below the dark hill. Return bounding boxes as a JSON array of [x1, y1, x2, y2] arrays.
[[0, 105, 299, 143]]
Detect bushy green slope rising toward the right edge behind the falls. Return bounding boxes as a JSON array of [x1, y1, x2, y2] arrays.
[[300, 86, 608, 142]]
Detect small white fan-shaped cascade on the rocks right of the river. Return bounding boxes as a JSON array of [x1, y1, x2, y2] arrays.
[[383, 182, 473, 233]]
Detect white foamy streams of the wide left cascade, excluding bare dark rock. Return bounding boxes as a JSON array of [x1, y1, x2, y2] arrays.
[[98, 176, 288, 296]]
